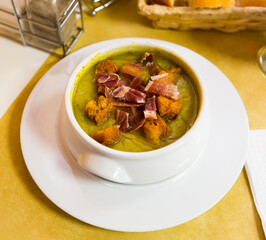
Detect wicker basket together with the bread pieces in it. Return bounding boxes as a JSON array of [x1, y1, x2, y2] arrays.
[[138, 0, 266, 32]]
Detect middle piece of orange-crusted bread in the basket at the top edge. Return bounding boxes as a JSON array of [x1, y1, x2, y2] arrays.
[[190, 0, 235, 8]]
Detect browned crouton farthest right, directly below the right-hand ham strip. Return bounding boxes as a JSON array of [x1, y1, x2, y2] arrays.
[[157, 95, 182, 119]]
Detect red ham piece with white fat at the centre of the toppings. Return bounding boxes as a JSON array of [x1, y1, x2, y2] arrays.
[[113, 86, 146, 103]]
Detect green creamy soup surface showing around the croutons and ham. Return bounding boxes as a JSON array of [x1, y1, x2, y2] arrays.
[[71, 49, 200, 152]]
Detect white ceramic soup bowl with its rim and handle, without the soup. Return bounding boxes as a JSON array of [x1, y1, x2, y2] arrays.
[[60, 39, 210, 184]]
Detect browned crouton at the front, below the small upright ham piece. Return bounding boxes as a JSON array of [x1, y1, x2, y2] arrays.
[[142, 115, 169, 145]]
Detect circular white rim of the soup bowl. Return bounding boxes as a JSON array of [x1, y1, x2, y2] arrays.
[[65, 39, 206, 159]]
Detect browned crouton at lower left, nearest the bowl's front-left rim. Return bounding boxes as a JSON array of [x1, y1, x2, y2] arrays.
[[92, 126, 120, 146]]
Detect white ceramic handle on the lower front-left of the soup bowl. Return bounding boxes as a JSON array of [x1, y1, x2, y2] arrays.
[[77, 153, 132, 183]]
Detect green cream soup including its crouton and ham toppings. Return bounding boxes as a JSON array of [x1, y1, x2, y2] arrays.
[[71, 48, 200, 152]]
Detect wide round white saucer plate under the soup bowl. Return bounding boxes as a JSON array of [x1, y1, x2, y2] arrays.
[[21, 38, 249, 232]]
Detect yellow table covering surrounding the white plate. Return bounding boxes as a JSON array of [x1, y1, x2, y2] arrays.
[[0, 0, 266, 240]]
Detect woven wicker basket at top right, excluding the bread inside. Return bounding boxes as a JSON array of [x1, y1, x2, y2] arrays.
[[138, 0, 266, 32]]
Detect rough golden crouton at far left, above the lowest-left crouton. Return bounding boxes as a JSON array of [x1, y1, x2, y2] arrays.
[[85, 96, 115, 124]]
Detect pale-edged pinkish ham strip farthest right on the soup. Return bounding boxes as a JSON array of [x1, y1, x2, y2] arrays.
[[144, 81, 180, 100]]
